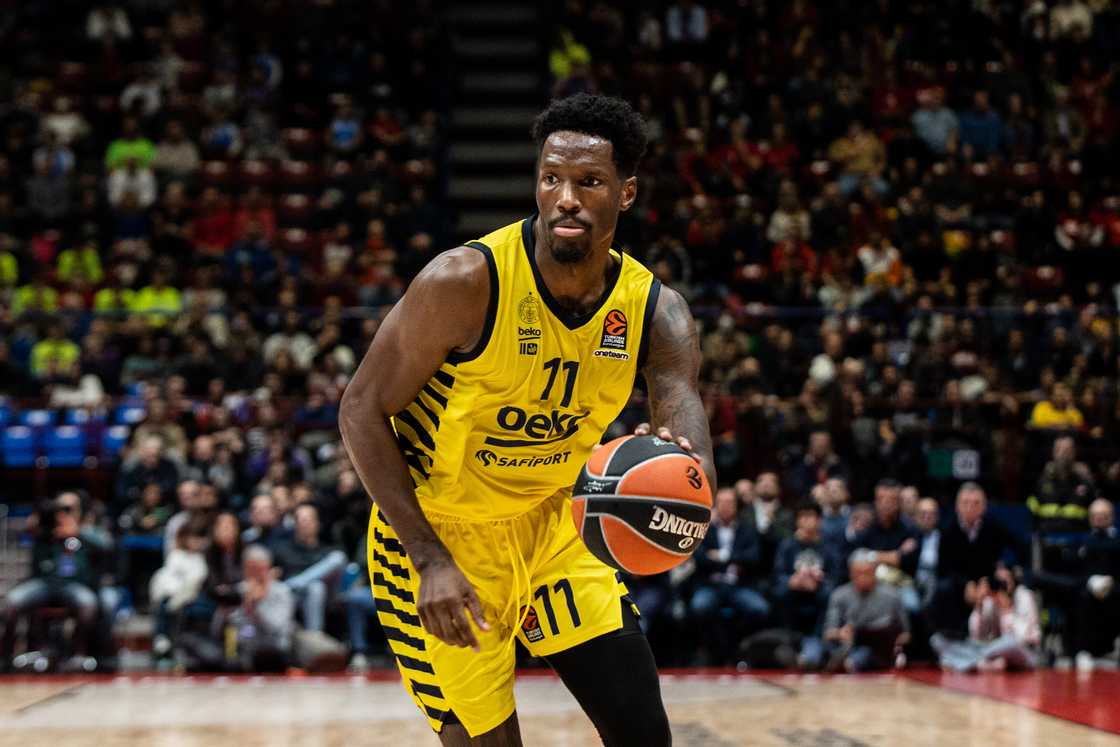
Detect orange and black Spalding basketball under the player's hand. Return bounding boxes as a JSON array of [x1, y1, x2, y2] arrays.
[[571, 436, 711, 576]]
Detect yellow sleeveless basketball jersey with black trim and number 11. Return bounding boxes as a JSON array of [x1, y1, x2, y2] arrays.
[[393, 218, 661, 521]]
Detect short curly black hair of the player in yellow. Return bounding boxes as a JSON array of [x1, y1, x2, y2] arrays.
[[532, 93, 648, 178]]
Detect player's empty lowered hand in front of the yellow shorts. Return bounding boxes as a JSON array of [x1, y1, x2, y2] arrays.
[[417, 559, 489, 652]]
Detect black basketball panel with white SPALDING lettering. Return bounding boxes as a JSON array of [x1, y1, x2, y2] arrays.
[[585, 496, 711, 552]]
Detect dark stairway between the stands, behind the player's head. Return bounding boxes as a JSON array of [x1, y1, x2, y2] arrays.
[[447, 0, 548, 242]]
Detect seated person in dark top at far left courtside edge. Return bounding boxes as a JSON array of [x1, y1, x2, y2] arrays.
[[0, 492, 112, 672]]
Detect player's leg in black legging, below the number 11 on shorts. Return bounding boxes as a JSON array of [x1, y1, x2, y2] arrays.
[[545, 601, 672, 747]]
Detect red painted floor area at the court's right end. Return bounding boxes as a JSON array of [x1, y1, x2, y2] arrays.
[[902, 670, 1120, 734]]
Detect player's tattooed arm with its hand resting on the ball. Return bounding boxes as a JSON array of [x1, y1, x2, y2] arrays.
[[634, 287, 716, 492]]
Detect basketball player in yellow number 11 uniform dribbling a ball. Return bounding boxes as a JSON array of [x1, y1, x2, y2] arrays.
[[339, 94, 716, 747]]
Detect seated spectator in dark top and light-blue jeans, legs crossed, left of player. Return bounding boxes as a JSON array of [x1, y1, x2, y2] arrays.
[[276, 503, 346, 631]]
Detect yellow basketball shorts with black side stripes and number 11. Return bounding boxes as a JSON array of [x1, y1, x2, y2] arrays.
[[366, 492, 626, 737]]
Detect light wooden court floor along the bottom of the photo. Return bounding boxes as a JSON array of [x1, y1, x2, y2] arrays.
[[0, 672, 1120, 747]]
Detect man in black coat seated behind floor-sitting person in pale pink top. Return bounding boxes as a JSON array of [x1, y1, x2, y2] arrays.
[[933, 483, 1024, 634]]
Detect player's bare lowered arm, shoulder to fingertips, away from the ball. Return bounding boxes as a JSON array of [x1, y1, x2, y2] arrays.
[[338, 248, 489, 647]]
